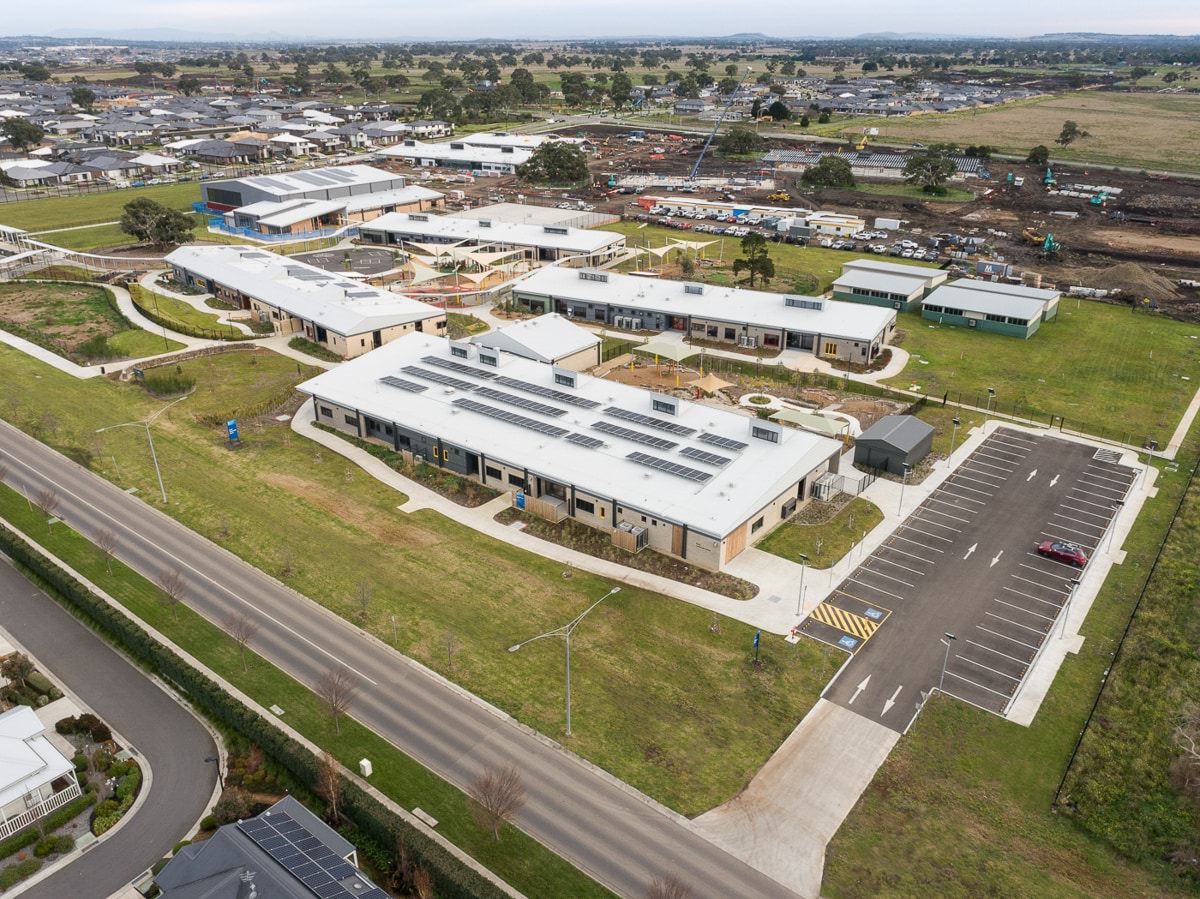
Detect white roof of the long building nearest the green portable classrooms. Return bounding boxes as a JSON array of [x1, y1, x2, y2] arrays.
[[512, 265, 895, 342]]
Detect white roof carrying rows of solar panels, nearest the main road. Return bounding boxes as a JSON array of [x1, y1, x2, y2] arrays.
[[299, 334, 840, 538]]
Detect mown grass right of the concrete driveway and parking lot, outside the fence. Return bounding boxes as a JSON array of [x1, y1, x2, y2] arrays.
[[821, 427, 1200, 899]]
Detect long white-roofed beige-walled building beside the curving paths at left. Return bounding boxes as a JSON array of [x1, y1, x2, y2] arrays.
[[166, 246, 446, 359]]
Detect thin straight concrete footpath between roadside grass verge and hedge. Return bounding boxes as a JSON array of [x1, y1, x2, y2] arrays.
[[0, 518, 526, 899]]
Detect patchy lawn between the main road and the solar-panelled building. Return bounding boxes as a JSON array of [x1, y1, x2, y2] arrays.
[[0, 340, 824, 815]]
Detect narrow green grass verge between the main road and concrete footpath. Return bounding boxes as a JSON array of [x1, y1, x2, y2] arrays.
[[0, 486, 612, 899]]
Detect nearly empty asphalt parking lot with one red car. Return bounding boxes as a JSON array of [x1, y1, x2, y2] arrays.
[[800, 427, 1138, 730]]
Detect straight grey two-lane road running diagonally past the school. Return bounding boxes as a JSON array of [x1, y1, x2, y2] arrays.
[[0, 422, 793, 899]]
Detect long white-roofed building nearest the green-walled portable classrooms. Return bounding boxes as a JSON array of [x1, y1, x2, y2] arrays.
[[512, 266, 896, 362]]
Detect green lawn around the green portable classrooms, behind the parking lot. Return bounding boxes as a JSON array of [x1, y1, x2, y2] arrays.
[[887, 298, 1200, 445]]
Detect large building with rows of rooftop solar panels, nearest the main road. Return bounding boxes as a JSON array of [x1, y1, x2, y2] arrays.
[[299, 335, 841, 570]]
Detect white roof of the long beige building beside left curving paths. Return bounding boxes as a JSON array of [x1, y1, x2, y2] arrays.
[[166, 246, 443, 336]]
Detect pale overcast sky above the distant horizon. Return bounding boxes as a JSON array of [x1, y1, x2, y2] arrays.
[[0, 0, 1200, 40]]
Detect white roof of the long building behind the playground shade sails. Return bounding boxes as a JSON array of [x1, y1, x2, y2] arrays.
[[361, 212, 625, 253]]
